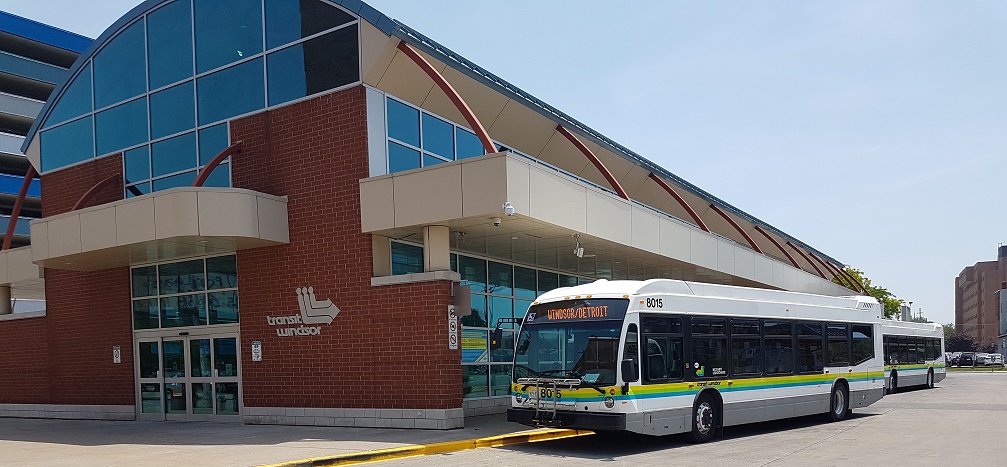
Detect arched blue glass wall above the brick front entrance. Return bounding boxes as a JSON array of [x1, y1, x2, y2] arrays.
[[39, 0, 359, 193]]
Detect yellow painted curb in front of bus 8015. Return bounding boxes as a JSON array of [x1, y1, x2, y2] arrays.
[[263, 430, 594, 467]]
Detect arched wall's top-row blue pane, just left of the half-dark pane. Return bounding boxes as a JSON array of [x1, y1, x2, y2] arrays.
[[195, 0, 262, 73]]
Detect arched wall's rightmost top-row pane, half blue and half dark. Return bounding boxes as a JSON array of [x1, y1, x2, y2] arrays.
[[266, 0, 354, 48]]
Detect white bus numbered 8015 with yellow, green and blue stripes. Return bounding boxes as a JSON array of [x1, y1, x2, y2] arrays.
[[508, 280, 884, 442]]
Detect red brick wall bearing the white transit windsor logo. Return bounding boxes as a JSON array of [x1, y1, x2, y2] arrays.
[[231, 87, 462, 409]]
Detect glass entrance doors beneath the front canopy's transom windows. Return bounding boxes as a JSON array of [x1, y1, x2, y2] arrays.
[[135, 333, 241, 422]]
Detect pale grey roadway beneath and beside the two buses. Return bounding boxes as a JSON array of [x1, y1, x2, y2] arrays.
[[382, 372, 1007, 467]]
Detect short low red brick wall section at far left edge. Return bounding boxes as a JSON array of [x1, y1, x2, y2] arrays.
[[0, 318, 49, 404]]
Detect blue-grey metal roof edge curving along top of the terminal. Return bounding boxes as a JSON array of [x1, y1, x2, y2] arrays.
[[21, 0, 843, 268]]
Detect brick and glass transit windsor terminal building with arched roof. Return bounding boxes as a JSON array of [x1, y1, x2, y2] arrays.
[[0, 0, 858, 429]]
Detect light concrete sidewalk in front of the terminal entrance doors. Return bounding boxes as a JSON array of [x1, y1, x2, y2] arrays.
[[0, 415, 576, 466]]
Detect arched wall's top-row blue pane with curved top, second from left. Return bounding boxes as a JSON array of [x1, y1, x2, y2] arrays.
[[94, 21, 147, 109]]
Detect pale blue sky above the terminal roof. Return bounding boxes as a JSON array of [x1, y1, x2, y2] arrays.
[[9, 0, 1007, 322]]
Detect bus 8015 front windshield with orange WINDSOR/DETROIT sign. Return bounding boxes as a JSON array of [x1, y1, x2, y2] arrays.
[[514, 299, 628, 386]]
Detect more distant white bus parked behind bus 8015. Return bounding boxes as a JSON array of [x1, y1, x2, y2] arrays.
[[881, 320, 948, 393]]
